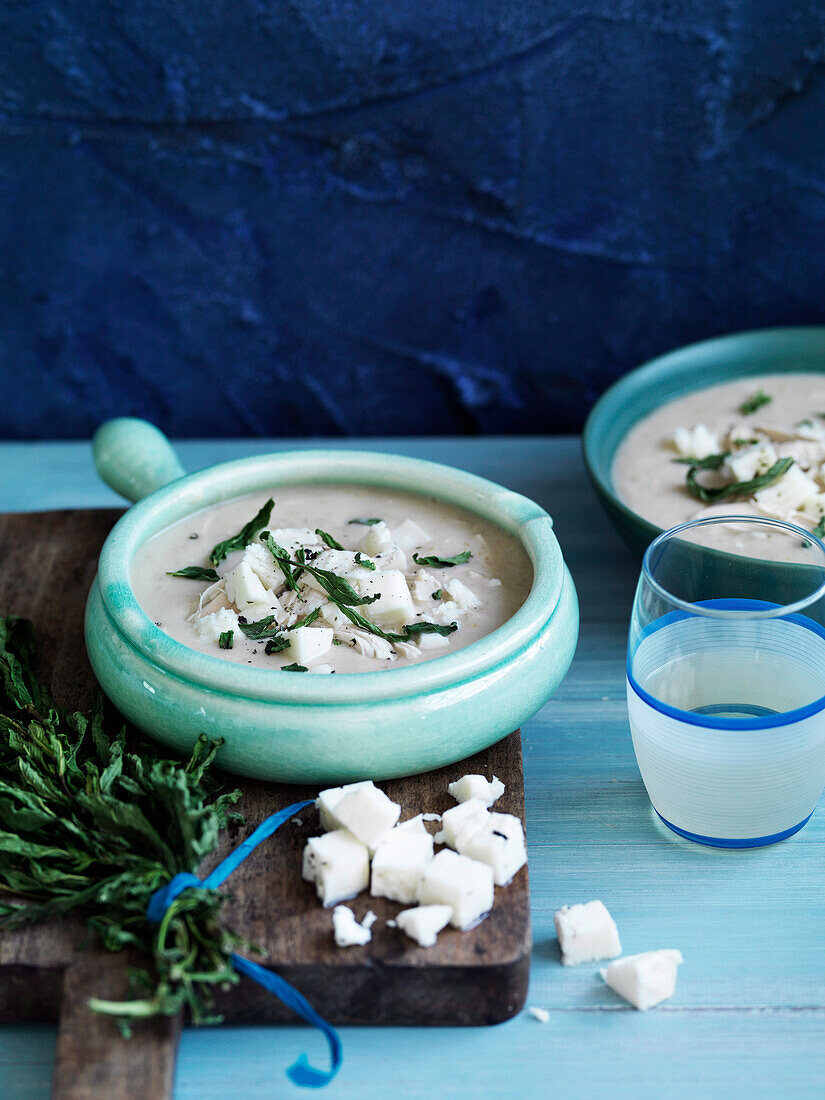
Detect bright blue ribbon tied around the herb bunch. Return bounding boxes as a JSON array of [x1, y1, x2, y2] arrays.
[[146, 801, 343, 1089]]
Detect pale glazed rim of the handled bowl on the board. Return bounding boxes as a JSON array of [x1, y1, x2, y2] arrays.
[[98, 450, 564, 699]]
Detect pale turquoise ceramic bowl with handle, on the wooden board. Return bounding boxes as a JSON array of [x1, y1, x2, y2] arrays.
[[86, 420, 579, 783]]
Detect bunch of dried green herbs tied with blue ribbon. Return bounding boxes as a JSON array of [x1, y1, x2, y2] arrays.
[[0, 617, 245, 1031]]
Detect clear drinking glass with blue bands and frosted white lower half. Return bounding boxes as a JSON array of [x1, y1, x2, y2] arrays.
[[627, 516, 825, 848]]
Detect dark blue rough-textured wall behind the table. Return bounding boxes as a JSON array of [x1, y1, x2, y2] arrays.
[[0, 0, 825, 438]]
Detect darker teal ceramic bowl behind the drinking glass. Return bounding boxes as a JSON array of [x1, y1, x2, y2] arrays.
[[583, 327, 825, 553]]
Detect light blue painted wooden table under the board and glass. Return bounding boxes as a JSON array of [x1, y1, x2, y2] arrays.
[[0, 438, 825, 1100]]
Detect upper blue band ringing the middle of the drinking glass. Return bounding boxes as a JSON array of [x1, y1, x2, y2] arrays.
[[627, 600, 825, 730]]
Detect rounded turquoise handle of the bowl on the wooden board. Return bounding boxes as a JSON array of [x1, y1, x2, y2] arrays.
[[91, 417, 186, 501]]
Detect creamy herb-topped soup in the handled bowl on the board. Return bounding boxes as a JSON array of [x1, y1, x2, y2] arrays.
[[131, 485, 532, 673]]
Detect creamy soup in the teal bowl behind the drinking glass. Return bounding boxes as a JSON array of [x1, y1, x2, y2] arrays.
[[612, 373, 825, 558]]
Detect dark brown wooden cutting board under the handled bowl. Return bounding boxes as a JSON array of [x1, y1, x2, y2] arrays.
[[0, 510, 531, 1100]]
